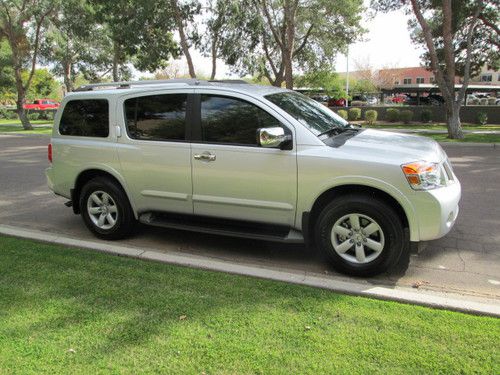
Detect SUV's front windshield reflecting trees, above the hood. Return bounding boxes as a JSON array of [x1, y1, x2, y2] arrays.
[[266, 92, 350, 135]]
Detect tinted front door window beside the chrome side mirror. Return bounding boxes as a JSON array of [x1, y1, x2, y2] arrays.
[[201, 95, 281, 146]]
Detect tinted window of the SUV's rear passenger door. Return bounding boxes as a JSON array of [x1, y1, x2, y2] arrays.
[[125, 94, 187, 141]]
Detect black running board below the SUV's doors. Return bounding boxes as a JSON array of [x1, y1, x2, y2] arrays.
[[139, 212, 304, 243]]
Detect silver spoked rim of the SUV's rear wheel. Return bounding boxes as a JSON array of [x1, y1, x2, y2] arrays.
[[87, 191, 118, 230]]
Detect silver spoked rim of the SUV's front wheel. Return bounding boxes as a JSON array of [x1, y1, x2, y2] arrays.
[[331, 213, 385, 264]]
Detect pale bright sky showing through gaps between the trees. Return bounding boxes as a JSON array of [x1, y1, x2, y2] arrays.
[[138, 0, 423, 78]]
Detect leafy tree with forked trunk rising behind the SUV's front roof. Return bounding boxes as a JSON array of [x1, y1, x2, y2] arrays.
[[215, 0, 363, 88]]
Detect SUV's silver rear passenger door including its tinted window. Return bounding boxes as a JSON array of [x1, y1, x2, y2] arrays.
[[118, 89, 193, 214]]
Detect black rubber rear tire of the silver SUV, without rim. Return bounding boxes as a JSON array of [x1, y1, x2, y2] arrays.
[[79, 177, 136, 240]]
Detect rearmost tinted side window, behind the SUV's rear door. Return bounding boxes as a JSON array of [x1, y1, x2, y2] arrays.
[[59, 99, 109, 138]]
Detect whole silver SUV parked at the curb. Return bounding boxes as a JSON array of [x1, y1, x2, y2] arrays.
[[46, 80, 460, 276]]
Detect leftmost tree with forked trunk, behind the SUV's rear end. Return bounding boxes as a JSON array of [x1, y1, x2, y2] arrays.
[[0, 0, 59, 130]]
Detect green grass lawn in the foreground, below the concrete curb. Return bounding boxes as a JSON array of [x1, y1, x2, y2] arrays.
[[0, 237, 500, 374]]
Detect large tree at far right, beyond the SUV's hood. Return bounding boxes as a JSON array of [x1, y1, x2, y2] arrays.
[[372, 0, 498, 139]]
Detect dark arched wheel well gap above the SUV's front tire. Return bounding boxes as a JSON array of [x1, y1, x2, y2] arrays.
[[306, 185, 409, 238]]
